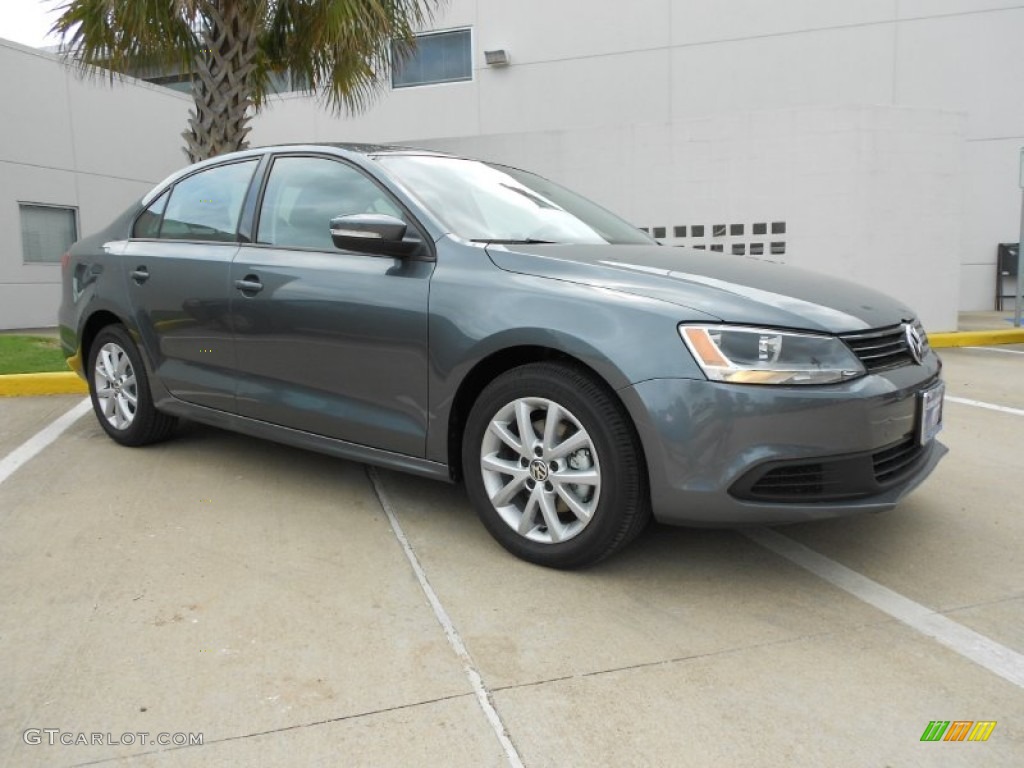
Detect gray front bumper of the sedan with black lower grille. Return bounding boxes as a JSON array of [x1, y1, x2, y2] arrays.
[[620, 353, 947, 525]]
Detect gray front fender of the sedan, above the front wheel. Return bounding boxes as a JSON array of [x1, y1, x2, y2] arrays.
[[427, 240, 714, 462]]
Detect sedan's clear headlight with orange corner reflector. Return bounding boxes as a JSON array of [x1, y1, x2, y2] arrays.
[[679, 326, 865, 384]]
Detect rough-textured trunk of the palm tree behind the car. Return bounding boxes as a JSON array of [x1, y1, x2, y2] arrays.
[[181, 0, 259, 163]]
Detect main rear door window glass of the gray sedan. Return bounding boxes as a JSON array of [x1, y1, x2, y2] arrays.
[[160, 160, 258, 242]]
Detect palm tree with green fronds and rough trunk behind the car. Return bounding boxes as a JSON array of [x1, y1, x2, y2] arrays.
[[53, 0, 443, 162]]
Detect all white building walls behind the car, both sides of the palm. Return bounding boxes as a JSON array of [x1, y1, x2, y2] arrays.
[[0, 0, 1024, 330]]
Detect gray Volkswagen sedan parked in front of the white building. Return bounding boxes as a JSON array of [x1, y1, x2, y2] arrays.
[[59, 144, 945, 567]]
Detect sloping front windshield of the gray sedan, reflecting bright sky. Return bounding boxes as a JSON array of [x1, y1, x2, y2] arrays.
[[377, 155, 654, 246]]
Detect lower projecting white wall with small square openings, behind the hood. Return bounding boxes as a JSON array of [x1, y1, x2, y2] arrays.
[[411, 108, 964, 330]]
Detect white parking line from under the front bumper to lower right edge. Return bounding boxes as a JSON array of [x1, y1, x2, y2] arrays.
[[740, 528, 1024, 688]]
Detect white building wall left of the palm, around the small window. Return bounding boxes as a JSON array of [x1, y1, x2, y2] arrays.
[[0, 40, 190, 329]]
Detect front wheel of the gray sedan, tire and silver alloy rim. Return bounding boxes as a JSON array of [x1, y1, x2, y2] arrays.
[[462, 362, 650, 568]]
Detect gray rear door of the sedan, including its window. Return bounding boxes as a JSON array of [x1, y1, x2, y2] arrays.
[[122, 158, 259, 411]]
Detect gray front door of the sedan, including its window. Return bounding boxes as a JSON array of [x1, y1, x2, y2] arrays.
[[230, 156, 433, 457]]
